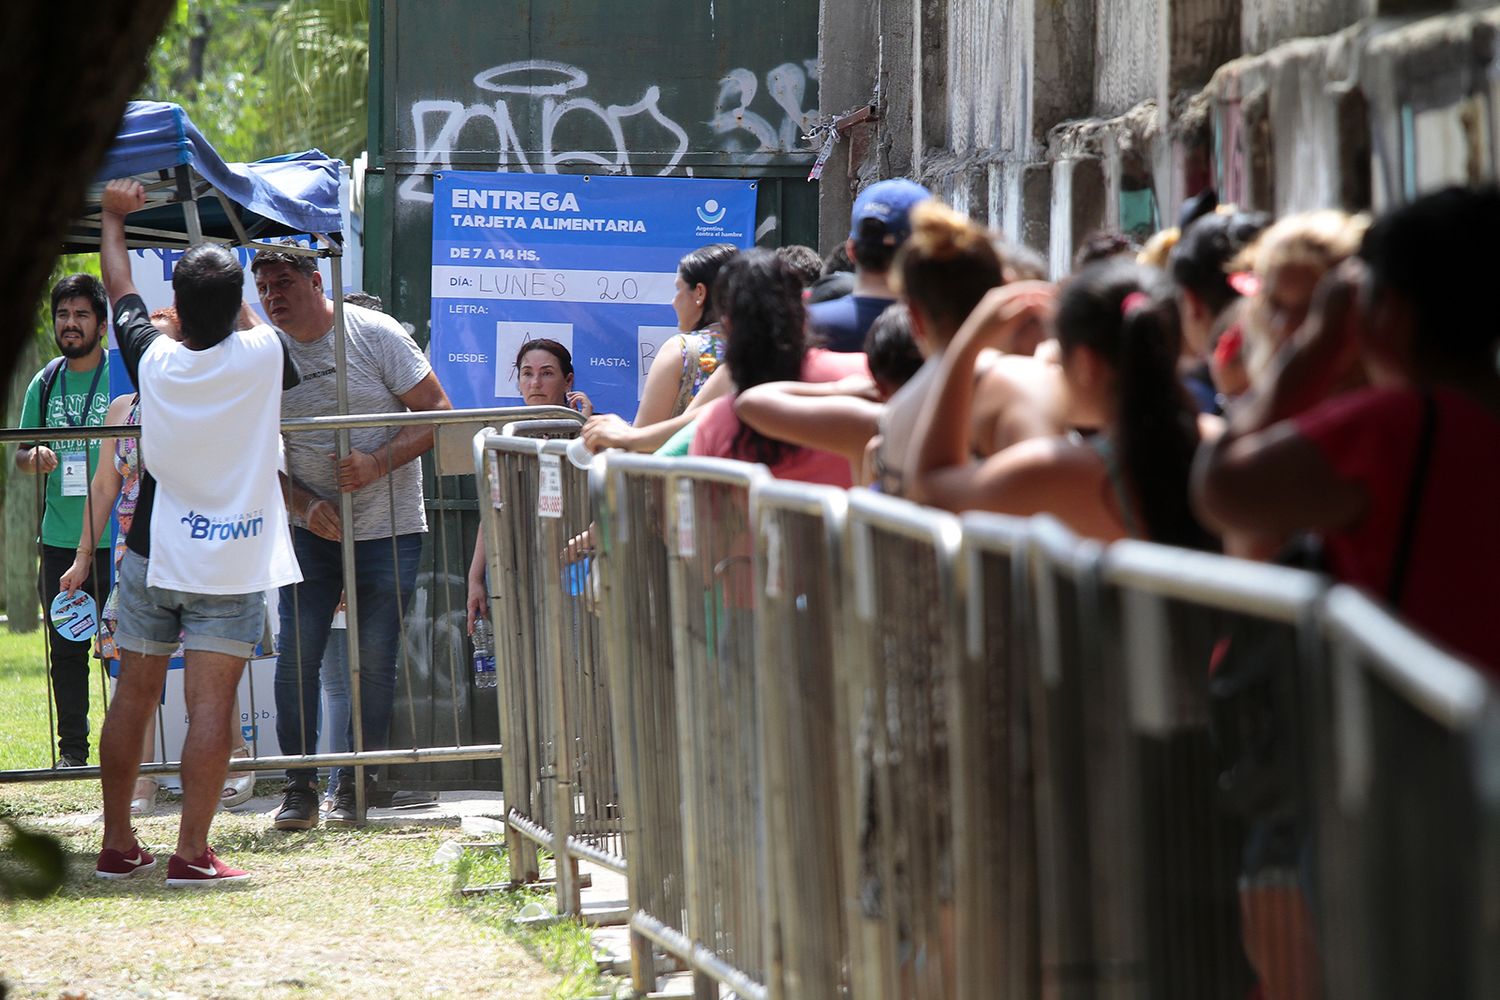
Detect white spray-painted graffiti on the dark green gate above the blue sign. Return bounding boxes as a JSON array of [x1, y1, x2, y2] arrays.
[[399, 58, 818, 201]]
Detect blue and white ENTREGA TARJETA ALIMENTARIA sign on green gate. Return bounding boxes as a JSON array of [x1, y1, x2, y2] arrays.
[[432, 172, 756, 420]]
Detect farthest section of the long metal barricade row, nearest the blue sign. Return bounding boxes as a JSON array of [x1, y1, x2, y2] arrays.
[[476, 421, 626, 915]]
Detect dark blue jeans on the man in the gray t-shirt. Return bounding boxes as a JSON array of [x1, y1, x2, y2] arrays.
[[276, 528, 422, 784]]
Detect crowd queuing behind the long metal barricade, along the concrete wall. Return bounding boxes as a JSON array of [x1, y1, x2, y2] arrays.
[[567, 180, 1500, 689]]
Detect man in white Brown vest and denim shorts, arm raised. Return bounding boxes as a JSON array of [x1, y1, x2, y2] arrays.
[[95, 180, 302, 888]]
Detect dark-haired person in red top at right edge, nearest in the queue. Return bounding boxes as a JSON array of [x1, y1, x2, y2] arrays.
[[1196, 187, 1500, 675]]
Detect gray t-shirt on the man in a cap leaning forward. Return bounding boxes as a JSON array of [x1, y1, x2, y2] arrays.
[[278, 304, 432, 541]]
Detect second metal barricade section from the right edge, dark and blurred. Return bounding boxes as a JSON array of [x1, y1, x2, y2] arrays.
[[1092, 541, 1326, 997]]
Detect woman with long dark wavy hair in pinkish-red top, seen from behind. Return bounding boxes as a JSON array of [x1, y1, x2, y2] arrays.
[[690, 250, 870, 487]]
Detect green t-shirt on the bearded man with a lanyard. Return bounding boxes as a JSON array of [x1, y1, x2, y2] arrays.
[[21, 355, 114, 549]]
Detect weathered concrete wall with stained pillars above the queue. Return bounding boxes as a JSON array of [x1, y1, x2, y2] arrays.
[[821, 0, 1500, 273]]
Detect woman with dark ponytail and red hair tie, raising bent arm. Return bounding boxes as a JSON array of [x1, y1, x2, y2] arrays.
[[912, 261, 1214, 549]]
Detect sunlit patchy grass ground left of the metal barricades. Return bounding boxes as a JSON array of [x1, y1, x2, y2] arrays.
[[0, 627, 609, 1000]]
